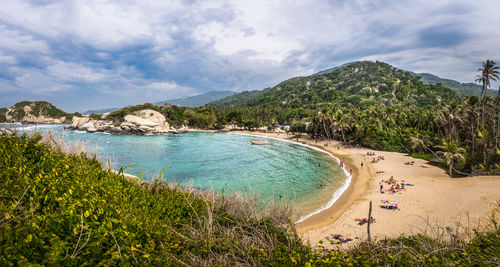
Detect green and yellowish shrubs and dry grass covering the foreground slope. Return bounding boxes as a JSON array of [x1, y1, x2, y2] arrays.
[[0, 131, 500, 266]]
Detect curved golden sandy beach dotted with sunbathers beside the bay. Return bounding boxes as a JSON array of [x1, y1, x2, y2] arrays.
[[215, 131, 500, 247]]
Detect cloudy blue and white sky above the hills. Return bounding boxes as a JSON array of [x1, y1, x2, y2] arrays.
[[0, 0, 500, 112]]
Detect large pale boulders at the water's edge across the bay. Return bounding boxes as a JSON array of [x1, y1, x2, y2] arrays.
[[71, 109, 187, 134]]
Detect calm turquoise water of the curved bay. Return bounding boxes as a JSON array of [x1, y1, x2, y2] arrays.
[[2, 125, 346, 218]]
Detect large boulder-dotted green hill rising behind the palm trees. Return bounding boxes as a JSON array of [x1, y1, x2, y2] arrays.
[[210, 61, 456, 108]]
